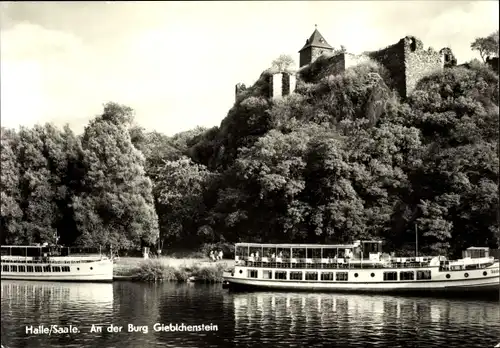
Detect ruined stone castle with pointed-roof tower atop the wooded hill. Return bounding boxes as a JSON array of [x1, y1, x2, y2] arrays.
[[236, 28, 458, 99]]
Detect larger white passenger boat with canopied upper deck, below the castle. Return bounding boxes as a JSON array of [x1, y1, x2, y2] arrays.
[[223, 241, 500, 294]]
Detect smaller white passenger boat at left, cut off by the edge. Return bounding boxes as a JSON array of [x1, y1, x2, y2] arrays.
[[1, 245, 113, 282]]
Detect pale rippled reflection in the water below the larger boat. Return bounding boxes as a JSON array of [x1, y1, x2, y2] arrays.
[[233, 293, 500, 347]]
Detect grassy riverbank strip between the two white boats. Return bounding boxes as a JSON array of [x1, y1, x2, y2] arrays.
[[114, 257, 234, 283]]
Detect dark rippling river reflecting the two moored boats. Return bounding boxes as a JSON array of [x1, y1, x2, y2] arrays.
[[1, 281, 500, 348]]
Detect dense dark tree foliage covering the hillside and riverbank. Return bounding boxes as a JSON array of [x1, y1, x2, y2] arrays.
[[1, 41, 500, 254]]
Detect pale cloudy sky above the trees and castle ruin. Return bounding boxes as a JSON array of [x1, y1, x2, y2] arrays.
[[0, 0, 499, 135]]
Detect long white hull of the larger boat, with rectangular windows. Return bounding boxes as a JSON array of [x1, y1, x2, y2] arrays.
[[223, 262, 500, 296]]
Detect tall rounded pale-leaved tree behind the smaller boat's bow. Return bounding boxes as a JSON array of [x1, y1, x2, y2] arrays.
[[73, 103, 158, 249]]
